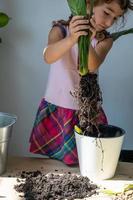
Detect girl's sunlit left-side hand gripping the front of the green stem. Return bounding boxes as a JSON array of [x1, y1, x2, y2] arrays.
[[69, 16, 89, 43]]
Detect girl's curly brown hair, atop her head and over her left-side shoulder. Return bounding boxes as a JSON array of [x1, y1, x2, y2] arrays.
[[53, 0, 133, 26]]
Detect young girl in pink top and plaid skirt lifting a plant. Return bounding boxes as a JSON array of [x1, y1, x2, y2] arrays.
[[30, 0, 133, 165]]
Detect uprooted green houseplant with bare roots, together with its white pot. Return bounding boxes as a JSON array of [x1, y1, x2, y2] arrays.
[[67, 0, 133, 179]]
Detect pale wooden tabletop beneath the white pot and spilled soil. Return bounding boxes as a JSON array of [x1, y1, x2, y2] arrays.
[[0, 157, 133, 200]]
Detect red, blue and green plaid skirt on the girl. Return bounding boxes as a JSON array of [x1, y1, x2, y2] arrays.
[[29, 99, 107, 165]]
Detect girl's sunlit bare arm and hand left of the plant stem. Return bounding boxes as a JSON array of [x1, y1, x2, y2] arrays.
[[43, 16, 89, 64]]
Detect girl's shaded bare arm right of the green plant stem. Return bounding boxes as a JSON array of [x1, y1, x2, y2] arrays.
[[88, 38, 113, 72]]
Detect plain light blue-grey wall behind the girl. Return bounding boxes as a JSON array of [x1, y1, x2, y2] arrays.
[[0, 0, 133, 156]]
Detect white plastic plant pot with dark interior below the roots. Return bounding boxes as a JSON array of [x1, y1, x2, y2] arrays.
[[75, 125, 125, 180]]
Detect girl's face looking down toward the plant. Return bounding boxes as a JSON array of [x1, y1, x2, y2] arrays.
[[88, 0, 124, 31]]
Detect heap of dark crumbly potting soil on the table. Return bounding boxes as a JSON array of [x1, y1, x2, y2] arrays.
[[14, 171, 98, 200]]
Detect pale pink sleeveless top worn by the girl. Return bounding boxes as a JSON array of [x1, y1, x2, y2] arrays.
[[44, 26, 97, 110]]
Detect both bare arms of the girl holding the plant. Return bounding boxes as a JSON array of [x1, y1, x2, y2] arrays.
[[43, 16, 113, 69]]
